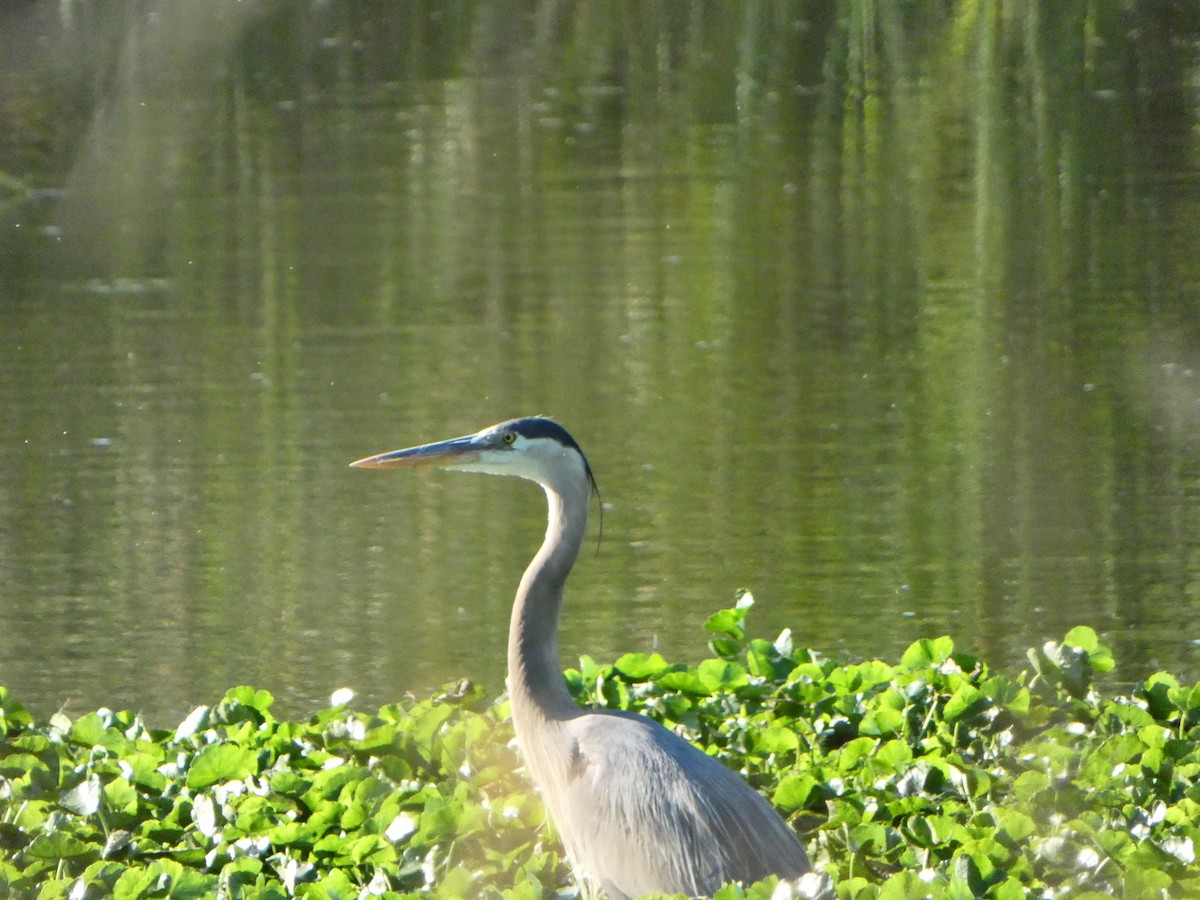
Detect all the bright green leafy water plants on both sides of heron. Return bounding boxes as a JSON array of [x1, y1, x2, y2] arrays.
[[0, 598, 1200, 900]]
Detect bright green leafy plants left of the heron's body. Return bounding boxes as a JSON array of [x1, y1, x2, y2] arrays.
[[0, 684, 569, 900]]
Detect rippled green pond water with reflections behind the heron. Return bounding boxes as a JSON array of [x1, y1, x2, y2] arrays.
[[0, 0, 1200, 725]]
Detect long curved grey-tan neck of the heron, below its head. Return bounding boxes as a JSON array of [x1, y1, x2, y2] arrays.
[[509, 485, 588, 724]]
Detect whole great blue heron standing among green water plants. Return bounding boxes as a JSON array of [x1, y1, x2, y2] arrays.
[[352, 418, 811, 900]]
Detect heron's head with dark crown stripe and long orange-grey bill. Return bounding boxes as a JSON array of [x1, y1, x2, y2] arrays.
[[350, 416, 596, 491]]
